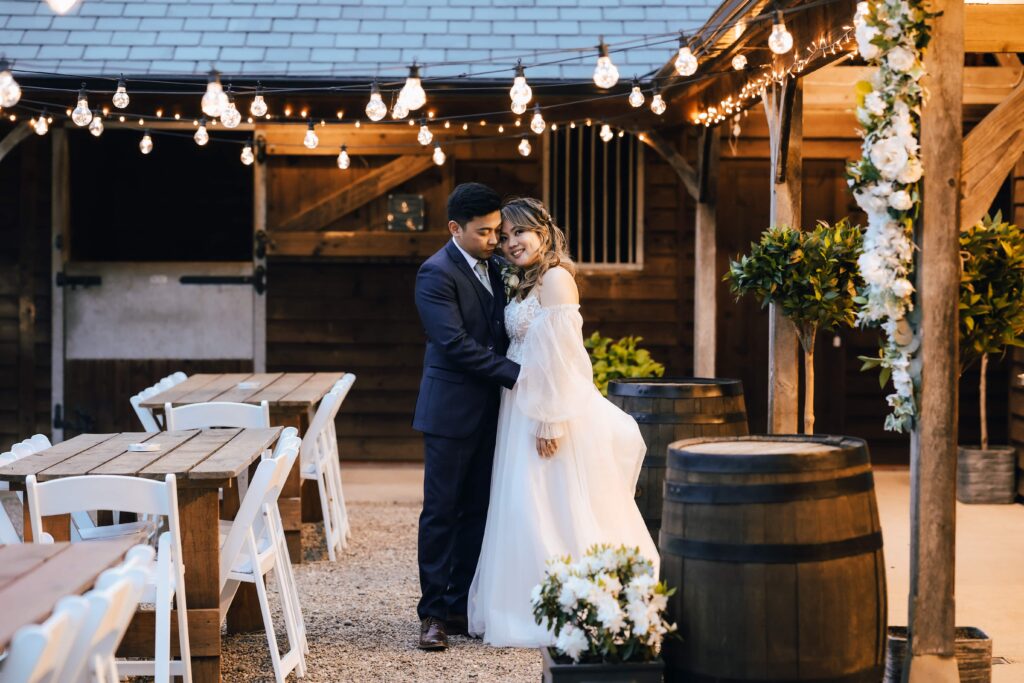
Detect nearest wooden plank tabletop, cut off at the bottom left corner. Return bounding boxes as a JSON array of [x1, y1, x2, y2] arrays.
[[0, 537, 140, 651]]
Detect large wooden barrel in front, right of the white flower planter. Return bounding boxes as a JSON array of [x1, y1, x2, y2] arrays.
[[659, 435, 886, 683]]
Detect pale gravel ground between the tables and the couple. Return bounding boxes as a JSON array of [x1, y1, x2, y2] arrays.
[[222, 503, 541, 683]]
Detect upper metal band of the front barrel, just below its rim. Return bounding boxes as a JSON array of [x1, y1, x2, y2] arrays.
[[665, 472, 874, 505]]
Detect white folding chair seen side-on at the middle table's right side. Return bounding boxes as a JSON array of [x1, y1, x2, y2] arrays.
[[220, 438, 308, 683]]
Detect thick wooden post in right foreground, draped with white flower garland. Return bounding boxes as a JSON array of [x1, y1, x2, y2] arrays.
[[903, 0, 964, 683]]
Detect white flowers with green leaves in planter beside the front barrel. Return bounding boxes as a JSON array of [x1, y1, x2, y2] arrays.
[[530, 545, 676, 663]]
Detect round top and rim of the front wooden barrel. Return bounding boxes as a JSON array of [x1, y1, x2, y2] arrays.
[[669, 434, 870, 472]]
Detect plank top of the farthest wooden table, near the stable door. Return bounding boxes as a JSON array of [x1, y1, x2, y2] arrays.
[[140, 373, 345, 409]]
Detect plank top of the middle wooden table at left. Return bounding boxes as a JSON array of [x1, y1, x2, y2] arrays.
[[0, 427, 282, 485]]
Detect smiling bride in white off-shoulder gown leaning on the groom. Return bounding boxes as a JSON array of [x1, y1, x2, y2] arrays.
[[468, 198, 658, 647]]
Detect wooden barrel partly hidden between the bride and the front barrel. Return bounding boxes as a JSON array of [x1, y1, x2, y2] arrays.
[[608, 377, 750, 543]]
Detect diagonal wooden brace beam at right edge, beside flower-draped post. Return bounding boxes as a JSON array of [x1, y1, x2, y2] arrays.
[[959, 75, 1024, 229]]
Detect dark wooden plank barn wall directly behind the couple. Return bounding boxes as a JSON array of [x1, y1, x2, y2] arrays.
[[267, 146, 692, 460]]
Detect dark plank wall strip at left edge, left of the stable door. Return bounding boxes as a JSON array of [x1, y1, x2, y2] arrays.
[[0, 135, 50, 451]]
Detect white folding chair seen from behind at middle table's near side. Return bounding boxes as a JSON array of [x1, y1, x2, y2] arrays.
[[26, 474, 191, 683]]
